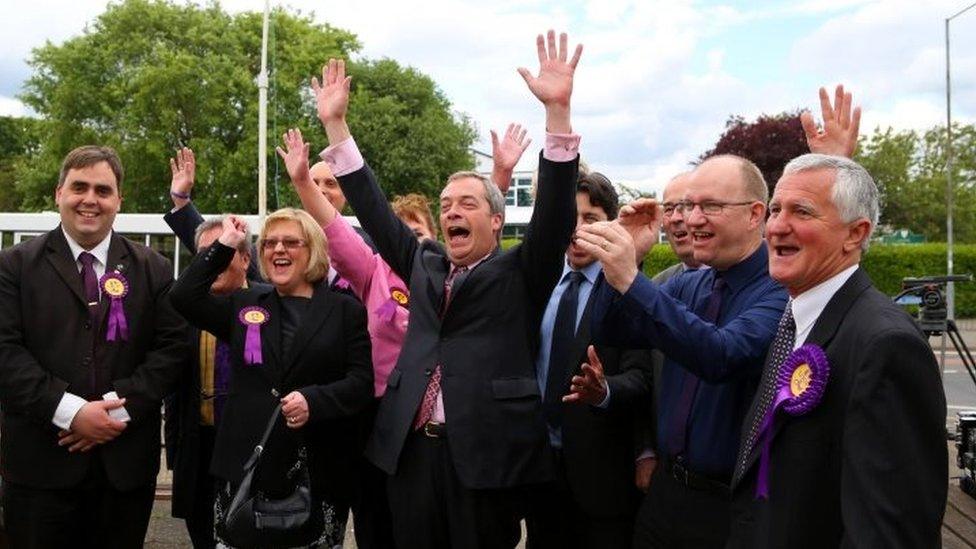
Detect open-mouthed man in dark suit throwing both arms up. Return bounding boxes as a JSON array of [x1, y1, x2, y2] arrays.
[[313, 31, 581, 548]]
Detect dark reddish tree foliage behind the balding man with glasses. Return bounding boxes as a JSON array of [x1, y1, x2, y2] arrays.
[[699, 112, 810, 196]]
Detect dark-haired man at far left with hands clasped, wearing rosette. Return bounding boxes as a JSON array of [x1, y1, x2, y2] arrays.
[[0, 146, 187, 547]]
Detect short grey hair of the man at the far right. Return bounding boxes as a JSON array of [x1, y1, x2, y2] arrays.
[[783, 154, 881, 251]]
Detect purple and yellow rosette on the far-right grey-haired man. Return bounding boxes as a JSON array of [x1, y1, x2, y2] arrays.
[[756, 343, 830, 499]]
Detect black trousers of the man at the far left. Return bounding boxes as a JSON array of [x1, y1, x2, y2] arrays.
[[3, 449, 156, 549]]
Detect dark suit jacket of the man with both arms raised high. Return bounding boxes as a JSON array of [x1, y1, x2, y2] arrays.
[[339, 155, 577, 488]]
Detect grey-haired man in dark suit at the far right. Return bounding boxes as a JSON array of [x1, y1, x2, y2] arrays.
[[729, 151, 948, 549]]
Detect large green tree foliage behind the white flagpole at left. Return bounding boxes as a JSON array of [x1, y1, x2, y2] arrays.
[[11, 0, 474, 213]]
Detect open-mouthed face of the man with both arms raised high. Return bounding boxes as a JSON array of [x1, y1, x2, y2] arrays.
[[440, 177, 502, 266]]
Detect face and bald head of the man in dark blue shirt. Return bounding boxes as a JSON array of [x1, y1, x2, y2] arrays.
[[684, 157, 766, 269]]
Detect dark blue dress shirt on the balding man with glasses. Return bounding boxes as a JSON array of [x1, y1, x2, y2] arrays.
[[591, 242, 787, 482]]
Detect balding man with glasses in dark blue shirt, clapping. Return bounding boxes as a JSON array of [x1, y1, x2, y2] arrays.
[[577, 156, 787, 548]]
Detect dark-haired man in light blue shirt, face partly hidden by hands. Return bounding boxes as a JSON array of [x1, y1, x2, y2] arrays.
[[526, 172, 653, 549]]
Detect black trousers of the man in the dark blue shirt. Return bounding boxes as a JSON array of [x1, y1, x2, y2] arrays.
[[634, 467, 731, 549]]
